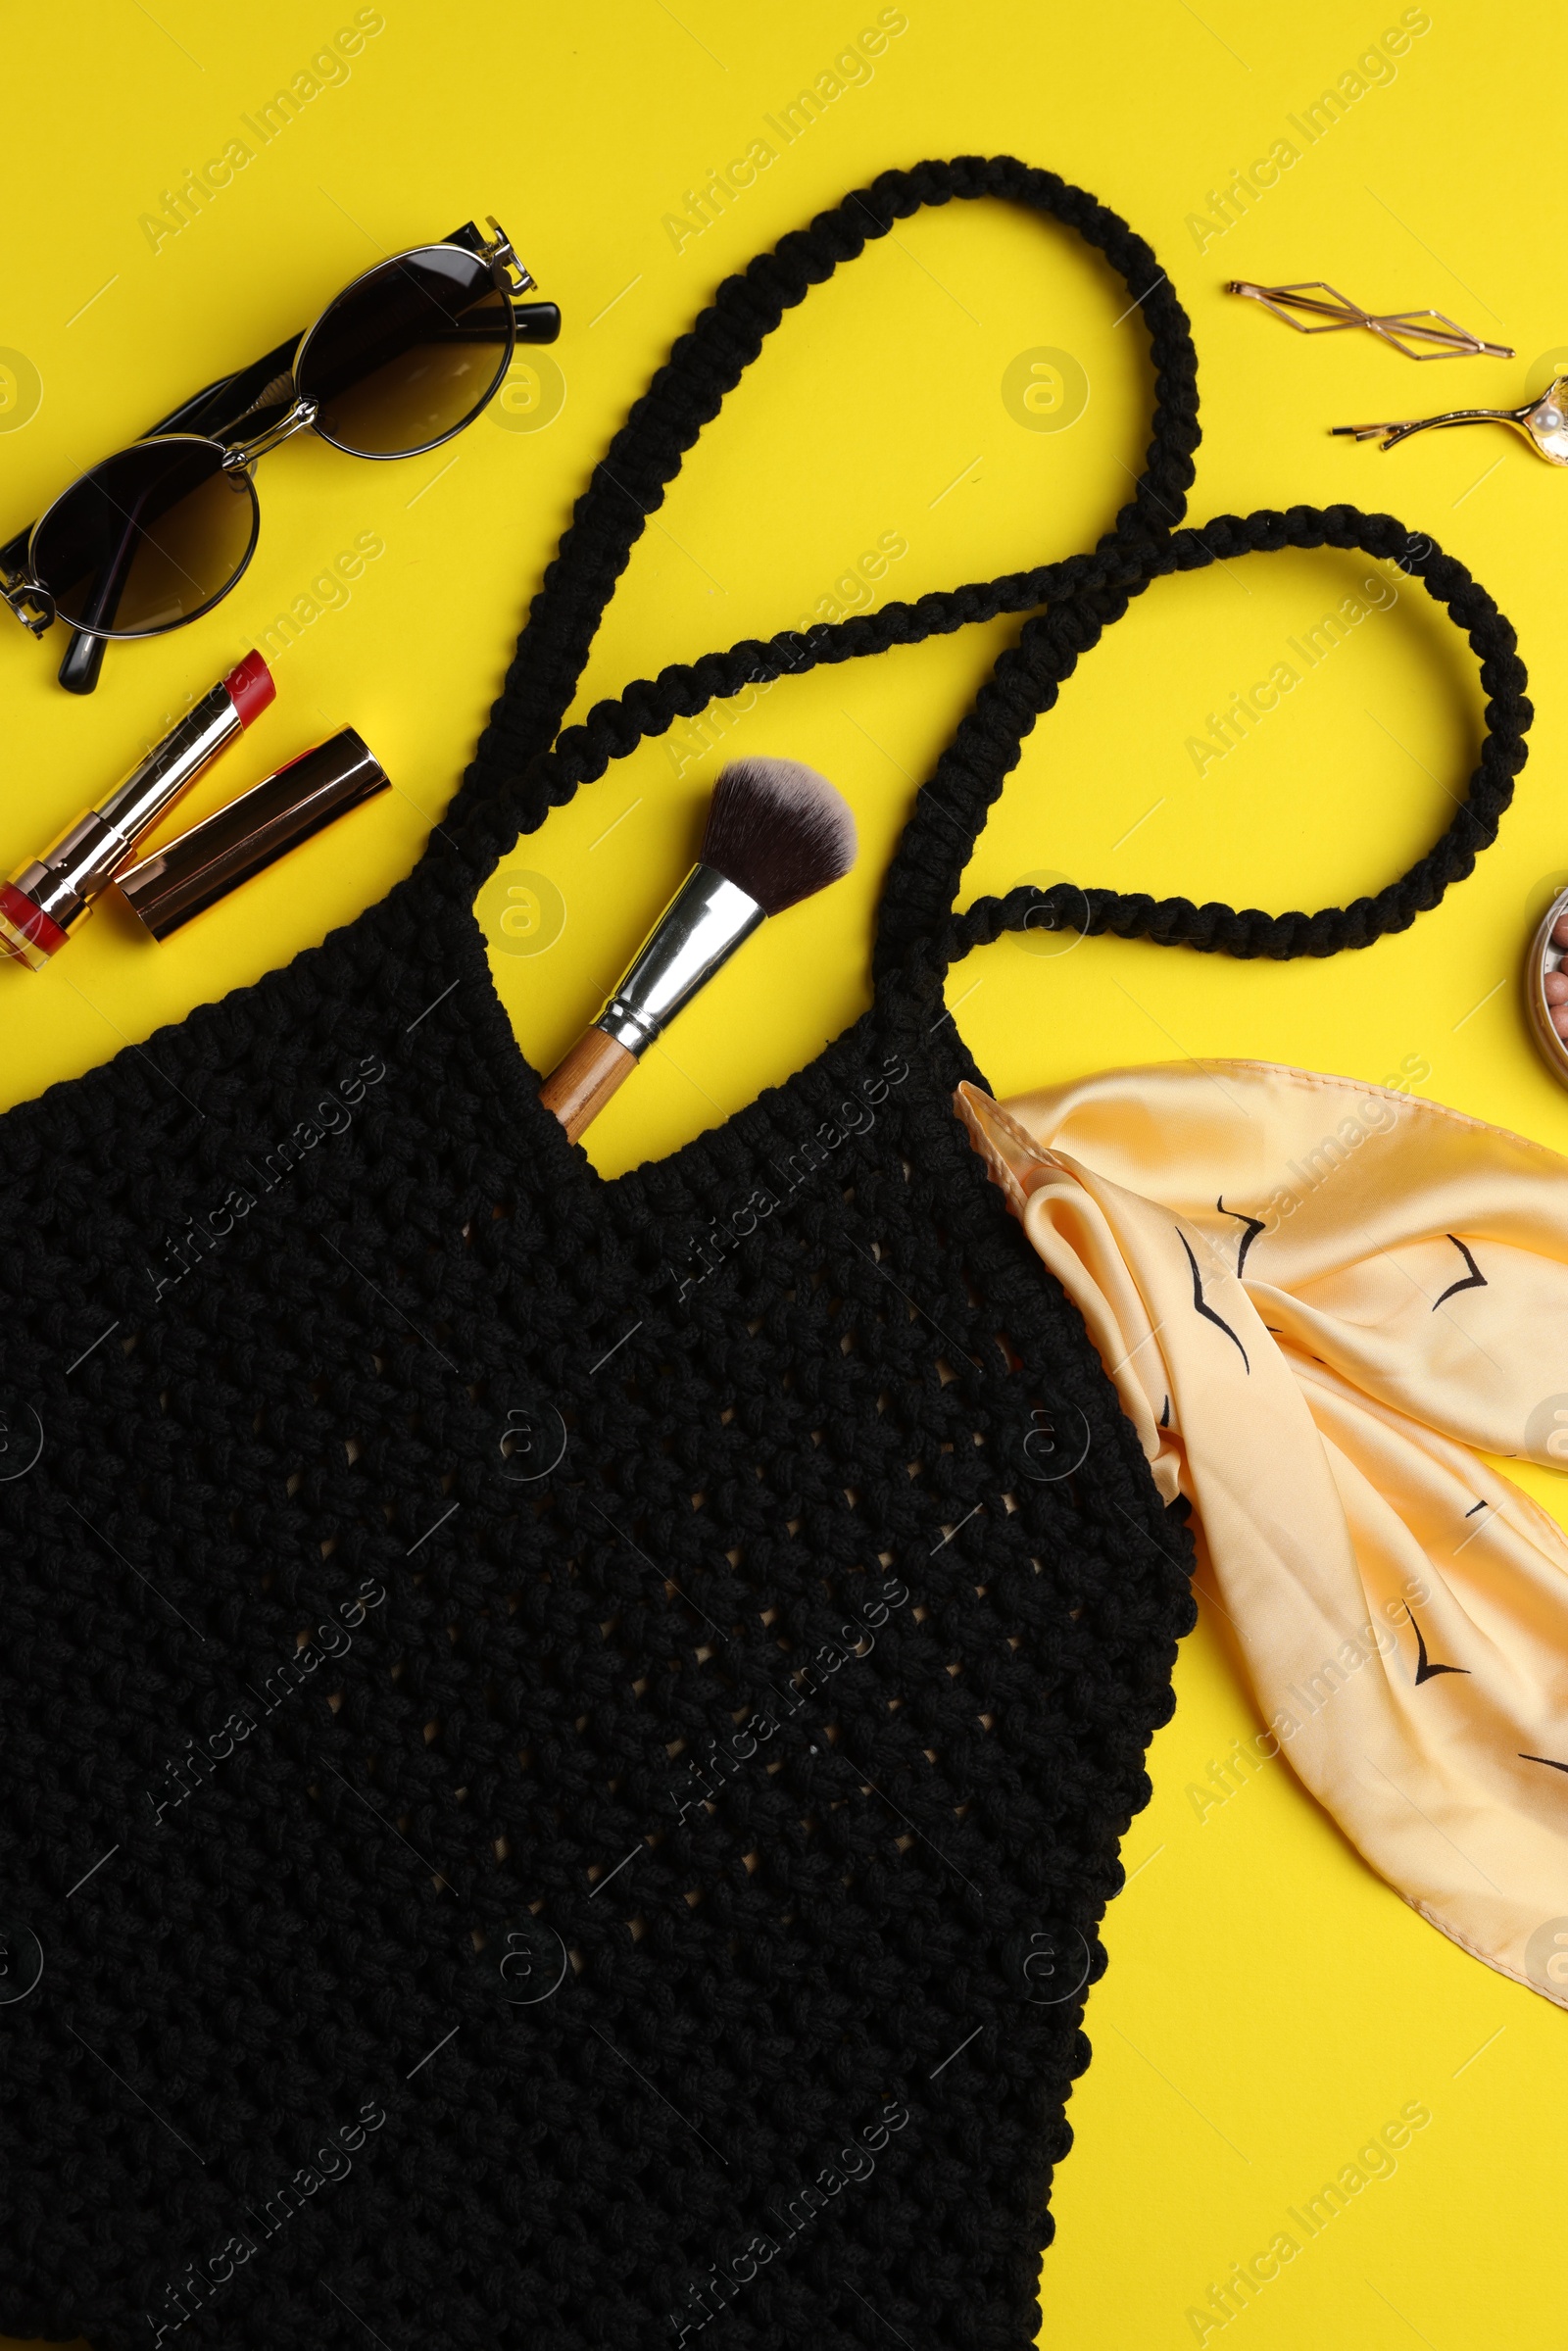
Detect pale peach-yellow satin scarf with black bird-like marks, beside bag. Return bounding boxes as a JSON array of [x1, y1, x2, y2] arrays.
[[959, 1060, 1568, 2008]]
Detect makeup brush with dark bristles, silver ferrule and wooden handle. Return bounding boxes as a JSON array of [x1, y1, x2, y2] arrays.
[[538, 759, 856, 1143]]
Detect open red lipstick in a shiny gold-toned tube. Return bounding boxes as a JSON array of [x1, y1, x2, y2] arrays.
[[0, 654, 277, 971]]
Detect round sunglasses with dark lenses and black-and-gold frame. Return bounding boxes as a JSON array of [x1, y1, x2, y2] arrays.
[[0, 219, 560, 637]]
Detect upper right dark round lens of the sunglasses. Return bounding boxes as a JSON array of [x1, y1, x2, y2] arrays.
[[294, 244, 513, 456]]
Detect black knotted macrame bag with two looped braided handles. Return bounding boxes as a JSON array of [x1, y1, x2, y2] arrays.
[[0, 158, 1528, 2351]]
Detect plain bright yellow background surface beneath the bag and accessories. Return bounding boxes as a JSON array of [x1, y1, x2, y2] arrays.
[[0, 0, 1568, 2351]]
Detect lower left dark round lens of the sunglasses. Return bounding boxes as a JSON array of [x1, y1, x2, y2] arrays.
[[33, 440, 256, 637]]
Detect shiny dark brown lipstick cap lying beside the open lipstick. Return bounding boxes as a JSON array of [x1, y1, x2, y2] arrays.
[[113, 726, 390, 938]]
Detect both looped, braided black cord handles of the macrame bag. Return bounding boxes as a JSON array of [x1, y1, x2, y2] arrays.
[[432, 155, 1533, 1004]]
